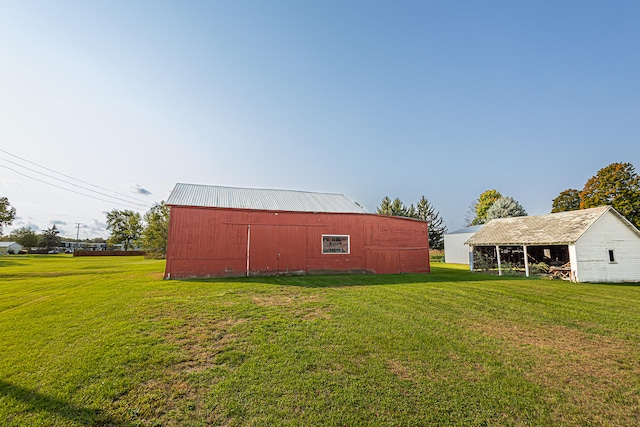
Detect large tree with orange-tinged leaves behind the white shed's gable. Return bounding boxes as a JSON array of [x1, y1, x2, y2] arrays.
[[580, 163, 640, 228]]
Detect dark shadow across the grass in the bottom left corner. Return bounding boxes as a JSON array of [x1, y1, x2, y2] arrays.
[[0, 380, 132, 427]]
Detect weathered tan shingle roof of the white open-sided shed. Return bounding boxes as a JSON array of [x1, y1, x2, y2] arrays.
[[465, 206, 638, 246]]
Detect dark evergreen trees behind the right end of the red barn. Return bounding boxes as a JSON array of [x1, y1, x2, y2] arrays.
[[376, 196, 447, 249]]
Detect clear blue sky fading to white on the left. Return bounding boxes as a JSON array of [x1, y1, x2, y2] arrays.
[[0, 0, 640, 238]]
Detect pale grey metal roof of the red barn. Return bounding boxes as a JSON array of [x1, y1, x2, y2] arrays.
[[167, 183, 366, 213]]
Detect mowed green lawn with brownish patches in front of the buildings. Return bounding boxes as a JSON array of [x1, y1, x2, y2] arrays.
[[0, 255, 640, 426]]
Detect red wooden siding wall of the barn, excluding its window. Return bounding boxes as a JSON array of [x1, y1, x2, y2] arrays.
[[165, 206, 430, 278]]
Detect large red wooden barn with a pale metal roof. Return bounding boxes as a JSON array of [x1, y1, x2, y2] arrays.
[[165, 184, 430, 279]]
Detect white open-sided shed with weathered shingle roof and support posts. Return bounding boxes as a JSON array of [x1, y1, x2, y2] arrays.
[[465, 206, 640, 283]]
